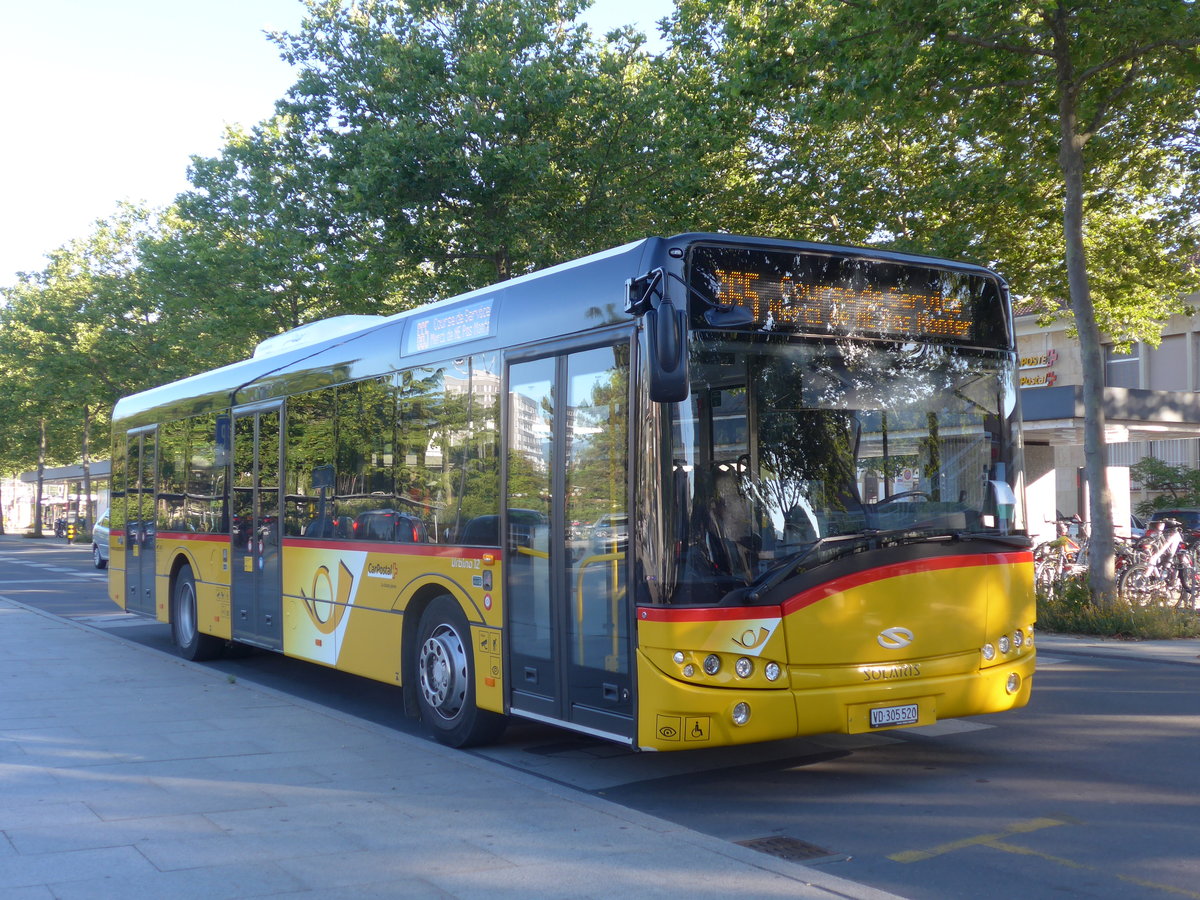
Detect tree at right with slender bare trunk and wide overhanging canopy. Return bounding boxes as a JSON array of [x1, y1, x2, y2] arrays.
[[674, 0, 1200, 607]]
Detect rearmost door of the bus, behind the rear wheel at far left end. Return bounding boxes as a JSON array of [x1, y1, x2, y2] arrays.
[[125, 427, 157, 616]]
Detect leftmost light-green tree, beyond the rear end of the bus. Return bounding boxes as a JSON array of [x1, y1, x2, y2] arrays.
[[0, 205, 219, 522]]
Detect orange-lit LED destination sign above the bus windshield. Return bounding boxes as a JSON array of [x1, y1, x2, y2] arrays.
[[691, 247, 1008, 348]]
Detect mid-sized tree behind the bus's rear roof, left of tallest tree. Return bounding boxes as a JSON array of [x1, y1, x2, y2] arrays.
[[139, 114, 402, 348]]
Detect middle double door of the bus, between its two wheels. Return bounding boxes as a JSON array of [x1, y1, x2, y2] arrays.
[[229, 406, 283, 649]]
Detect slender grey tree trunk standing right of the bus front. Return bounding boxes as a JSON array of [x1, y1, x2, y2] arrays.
[[1058, 37, 1116, 606]]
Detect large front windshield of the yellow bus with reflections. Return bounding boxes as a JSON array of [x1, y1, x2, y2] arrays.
[[672, 331, 1022, 602]]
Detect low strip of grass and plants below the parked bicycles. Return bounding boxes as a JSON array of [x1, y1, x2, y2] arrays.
[[1038, 580, 1200, 641]]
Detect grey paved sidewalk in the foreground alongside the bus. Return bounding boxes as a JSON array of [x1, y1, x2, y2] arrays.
[[0, 598, 890, 900]]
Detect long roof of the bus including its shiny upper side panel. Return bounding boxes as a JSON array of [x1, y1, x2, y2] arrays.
[[113, 233, 998, 428]]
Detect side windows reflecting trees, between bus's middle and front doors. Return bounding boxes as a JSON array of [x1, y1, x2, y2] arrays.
[[278, 355, 499, 544]]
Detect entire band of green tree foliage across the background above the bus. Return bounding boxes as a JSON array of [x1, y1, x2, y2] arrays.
[[0, 0, 1200, 513]]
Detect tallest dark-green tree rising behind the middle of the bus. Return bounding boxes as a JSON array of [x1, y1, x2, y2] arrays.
[[267, 0, 707, 300]]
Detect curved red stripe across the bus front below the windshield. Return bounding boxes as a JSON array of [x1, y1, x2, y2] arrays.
[[637, 551, 1033, 622]]
